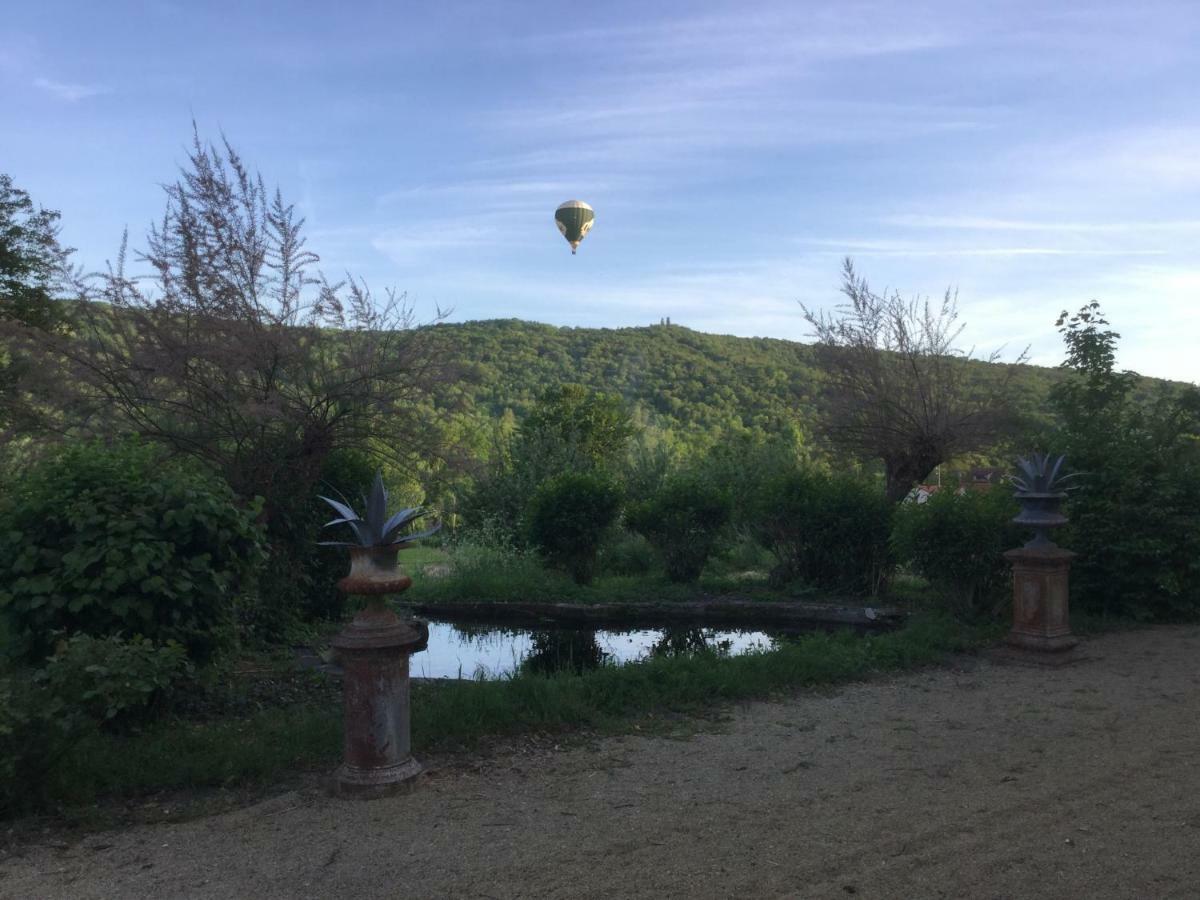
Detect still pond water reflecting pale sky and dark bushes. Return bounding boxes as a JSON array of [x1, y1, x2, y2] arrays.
[[409, 622, 782, 678]]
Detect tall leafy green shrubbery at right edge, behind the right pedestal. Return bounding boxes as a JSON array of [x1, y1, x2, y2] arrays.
[[1051, 302, 1200, 619]]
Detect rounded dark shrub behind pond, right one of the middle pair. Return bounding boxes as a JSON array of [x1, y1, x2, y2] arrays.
[[625, 473, 730, 582]]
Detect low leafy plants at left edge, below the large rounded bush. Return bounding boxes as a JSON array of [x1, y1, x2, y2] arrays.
[[0, 635, 188, 810]]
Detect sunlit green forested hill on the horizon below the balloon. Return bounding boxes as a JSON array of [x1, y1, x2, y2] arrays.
[[434, 319, 1056, 443]]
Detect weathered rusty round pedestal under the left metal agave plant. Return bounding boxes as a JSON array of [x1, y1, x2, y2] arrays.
[[331, 599, 430, 799]]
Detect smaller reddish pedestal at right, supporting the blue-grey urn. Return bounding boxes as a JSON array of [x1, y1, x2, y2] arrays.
[[1004, 544, 1079, 659]]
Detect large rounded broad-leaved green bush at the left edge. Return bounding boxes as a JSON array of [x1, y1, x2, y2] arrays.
[[0, 443, 263, 661]]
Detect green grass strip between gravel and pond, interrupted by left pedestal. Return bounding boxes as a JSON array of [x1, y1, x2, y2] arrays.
[[32, 618, 989, 806]]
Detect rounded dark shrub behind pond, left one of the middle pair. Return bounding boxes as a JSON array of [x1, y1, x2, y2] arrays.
[[529, 472, 620, 584]]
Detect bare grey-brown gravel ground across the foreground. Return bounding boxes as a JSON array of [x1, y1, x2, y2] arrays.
[[0, 628, 1200, 898]]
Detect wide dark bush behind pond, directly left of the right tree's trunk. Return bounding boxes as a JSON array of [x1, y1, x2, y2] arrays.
[[751, 468, 893, 595]]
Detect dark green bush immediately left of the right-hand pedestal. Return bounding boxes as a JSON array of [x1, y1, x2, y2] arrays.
[[892, 487, 1025, 617]]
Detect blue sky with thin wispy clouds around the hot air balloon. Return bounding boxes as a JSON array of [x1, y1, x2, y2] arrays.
[[0, 0, 1200, 380]]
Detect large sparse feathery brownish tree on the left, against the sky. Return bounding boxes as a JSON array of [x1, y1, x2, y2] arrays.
[[11, 134, 446, 518]]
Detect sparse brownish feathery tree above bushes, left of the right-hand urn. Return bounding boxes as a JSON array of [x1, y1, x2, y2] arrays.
[[802, 258, 1025, 502]]
